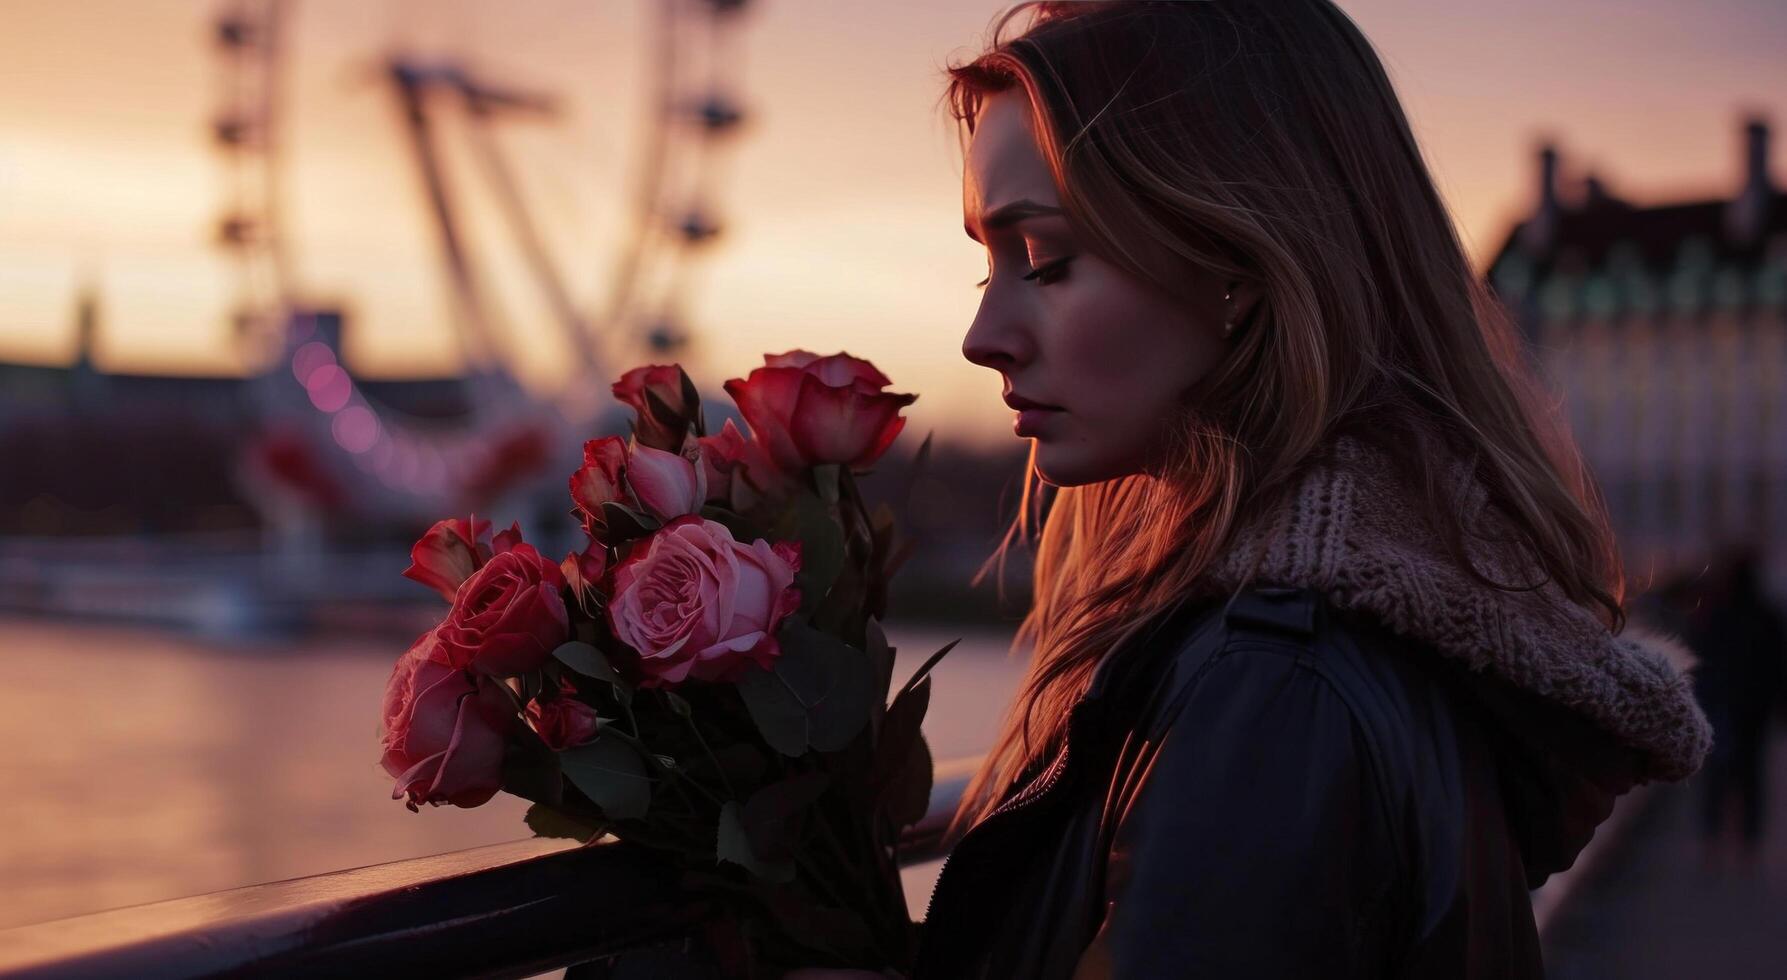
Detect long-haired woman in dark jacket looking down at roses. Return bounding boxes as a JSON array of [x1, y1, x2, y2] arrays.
[[804, 0, 1708, 978]]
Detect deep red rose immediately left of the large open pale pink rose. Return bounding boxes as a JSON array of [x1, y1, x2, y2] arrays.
[[438, 544, 570, 678]]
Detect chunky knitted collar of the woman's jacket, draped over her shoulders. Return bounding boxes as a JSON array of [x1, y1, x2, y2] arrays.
[[1200, 436, 1712, 780]]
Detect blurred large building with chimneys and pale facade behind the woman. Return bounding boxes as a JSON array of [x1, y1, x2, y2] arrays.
[[1489, 118, 1787, 572]]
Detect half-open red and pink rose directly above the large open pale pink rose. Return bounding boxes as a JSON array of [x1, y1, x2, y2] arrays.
[[570, 436, 708, 535]]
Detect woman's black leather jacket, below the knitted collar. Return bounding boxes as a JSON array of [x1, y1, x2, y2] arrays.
[[915, 588, 1637, 980]]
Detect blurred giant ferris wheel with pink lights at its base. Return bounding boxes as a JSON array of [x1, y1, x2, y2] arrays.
[[211, 0, 747, 519]]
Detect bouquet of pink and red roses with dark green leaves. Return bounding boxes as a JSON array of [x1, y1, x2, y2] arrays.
[[382, 351, 952, 969]]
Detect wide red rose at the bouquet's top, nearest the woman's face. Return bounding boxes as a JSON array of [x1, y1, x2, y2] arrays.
[[726, 351, 919, 472]]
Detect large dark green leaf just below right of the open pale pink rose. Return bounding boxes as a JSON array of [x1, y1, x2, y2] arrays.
[[738, 621, 874, 756]]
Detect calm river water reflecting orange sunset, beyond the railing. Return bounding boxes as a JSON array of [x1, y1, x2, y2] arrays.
[[0, 619, 1020, 928]]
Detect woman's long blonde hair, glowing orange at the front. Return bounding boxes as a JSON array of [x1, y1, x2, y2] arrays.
[[944, 0, 1624, 830]]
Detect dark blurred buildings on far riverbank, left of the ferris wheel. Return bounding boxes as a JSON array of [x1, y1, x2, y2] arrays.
[[0, 295, 470, 535]]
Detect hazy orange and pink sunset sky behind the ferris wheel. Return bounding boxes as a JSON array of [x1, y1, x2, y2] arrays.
[[0, 0, 1787, 443]]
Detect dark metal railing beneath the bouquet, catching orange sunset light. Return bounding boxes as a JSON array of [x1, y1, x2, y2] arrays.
[[0, 758, 977, 980]]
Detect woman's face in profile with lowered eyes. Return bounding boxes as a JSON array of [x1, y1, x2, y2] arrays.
[[961, 89, 1253, 486]]
